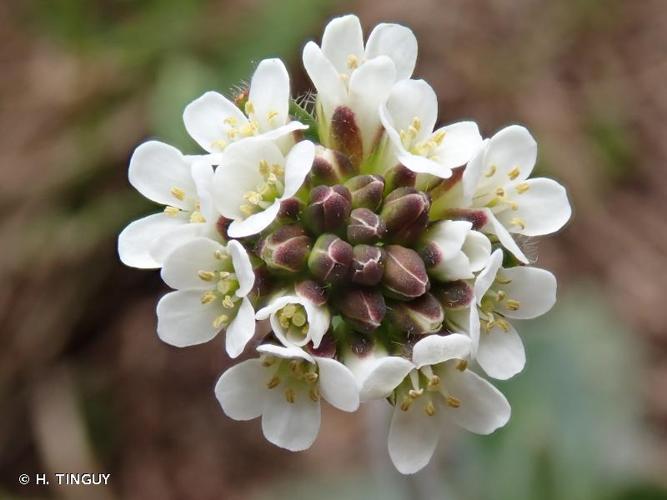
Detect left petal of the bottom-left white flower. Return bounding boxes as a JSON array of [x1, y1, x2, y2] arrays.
[[215, 359, 268, 420]]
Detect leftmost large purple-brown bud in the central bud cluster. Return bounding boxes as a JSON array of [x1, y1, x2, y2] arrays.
[[257, 225, 310, 272]]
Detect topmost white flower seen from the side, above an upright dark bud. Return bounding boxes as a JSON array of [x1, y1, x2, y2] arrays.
[[303, 15, 417, 156]]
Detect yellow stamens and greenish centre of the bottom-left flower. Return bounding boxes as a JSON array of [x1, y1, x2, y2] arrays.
[[260, 355, 320, 403]]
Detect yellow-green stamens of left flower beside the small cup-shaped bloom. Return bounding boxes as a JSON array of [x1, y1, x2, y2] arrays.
[[197, 250, 241, 328]]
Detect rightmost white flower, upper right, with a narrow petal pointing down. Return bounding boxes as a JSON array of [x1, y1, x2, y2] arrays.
[[462, 125, 572, 263]]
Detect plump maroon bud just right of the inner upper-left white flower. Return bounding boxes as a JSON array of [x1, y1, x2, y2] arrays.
[[303, 184, 352, 234]]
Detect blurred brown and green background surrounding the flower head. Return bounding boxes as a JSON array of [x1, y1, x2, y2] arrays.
[[0, 0, 667, 500]]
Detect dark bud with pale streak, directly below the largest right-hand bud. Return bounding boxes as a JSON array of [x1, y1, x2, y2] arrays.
[[390, 293, 445, 335]]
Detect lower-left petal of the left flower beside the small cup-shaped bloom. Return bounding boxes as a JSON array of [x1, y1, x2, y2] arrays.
[[157, 290, 222, 347]]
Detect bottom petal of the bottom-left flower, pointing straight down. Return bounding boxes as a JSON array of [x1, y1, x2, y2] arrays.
[[262, 386, 320, 451]]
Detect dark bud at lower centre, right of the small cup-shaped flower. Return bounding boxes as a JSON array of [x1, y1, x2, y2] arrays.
[[337, 288, 387, 333]]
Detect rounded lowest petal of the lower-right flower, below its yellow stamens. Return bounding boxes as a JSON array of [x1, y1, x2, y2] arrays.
[[477, 323, 526, 380]]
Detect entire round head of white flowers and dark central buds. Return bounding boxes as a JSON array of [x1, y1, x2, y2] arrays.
[[118, 15, 571, 474]]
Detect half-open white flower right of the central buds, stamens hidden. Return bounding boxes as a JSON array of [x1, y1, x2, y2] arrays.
[[422, 221, 491, 281]]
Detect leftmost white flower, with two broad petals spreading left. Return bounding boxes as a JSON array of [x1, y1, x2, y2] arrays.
[[118, 141, 220, 269]]
